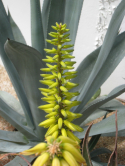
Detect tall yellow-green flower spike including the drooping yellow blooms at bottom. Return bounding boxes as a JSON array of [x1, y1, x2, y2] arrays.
[[20, 23, 87, 166]]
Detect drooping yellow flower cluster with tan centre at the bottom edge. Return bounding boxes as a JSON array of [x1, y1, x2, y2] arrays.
[[20, 136, 87, 166]]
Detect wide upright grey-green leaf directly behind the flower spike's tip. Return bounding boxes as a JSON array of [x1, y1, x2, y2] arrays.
[[42, 0, 83, 48]]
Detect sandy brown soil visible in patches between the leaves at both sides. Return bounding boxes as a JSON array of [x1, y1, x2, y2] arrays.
[[0, 65, 125, 166]]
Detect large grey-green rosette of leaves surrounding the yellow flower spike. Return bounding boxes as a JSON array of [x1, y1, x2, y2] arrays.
[[0, 0, 125, 166]]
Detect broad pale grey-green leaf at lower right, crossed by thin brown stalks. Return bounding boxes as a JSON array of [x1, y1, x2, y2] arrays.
[[74, 106, 125, 139]]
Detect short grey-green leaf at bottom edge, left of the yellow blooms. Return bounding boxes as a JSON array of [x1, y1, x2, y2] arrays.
[[5, 156, 35, 166]]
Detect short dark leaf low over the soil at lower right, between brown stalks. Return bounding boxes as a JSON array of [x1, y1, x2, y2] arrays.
[[90, 148, 112, 158]]
